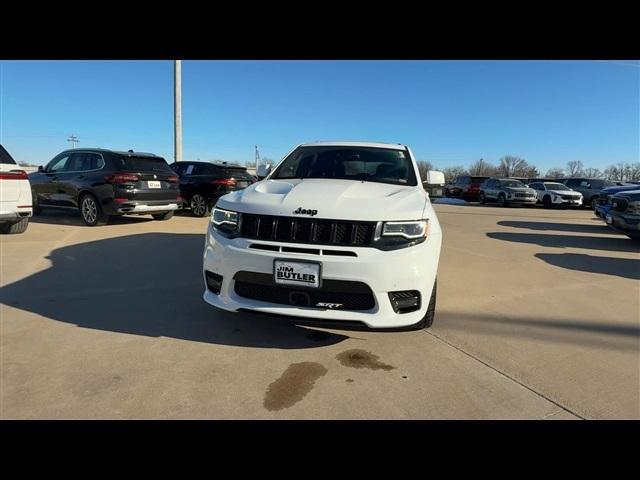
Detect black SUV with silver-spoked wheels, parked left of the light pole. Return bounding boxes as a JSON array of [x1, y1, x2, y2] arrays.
[[29, 148, 180, 226]]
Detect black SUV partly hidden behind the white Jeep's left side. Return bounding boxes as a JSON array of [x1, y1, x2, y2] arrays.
[[171, 161, 255, 217]]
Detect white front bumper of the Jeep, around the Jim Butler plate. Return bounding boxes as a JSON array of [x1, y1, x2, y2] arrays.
[[203, 227, 442, 328]]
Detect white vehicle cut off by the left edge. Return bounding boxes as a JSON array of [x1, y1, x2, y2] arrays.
[[0, 145, 33, 233]]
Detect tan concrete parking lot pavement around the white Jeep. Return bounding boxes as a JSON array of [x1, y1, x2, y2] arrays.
[[0, 205, 640, 419]]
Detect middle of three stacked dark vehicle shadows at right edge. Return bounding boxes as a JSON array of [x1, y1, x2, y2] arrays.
[[487, 232, 640, 253]]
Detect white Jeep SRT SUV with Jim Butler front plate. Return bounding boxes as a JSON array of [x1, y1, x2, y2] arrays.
[[203, 142, 444, 328]]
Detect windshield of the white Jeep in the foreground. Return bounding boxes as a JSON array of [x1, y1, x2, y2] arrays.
[[270, 147, 418, 186]]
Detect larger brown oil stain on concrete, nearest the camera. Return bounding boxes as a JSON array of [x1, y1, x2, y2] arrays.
[[264, 362, 327, 411]]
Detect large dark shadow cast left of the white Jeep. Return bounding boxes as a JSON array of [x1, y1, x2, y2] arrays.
[[0, 233, 349, 349]]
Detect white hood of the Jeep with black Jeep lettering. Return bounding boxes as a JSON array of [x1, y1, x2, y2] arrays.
[[217, 178, 428, 221]]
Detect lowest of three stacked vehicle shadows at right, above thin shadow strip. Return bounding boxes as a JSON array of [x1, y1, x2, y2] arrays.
[[535, 253, 640, 280]]
